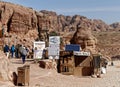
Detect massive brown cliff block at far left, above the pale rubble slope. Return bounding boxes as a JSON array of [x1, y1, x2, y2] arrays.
[[0, 2, 37, 33]]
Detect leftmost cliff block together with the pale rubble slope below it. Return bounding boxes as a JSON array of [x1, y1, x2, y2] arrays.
[[0, 2, 38, 46]]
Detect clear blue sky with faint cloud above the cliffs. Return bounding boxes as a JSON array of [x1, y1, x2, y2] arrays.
[[3, 0, 120, 24]]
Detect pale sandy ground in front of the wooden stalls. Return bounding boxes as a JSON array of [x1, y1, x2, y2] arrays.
[[0, 59, 120, 87]]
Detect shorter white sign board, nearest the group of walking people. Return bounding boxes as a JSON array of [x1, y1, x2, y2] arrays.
[[34, 41, 45, 59]]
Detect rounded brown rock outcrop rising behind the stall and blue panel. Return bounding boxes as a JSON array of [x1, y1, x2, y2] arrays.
[[71, 25, 97, 53]]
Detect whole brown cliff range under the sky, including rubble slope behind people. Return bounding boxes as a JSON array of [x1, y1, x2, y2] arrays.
[[0, 1, 111, 51]]
